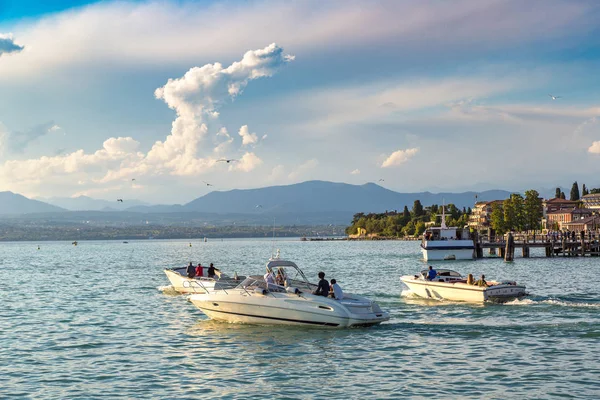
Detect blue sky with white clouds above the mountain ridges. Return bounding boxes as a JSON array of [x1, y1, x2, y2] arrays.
[[0, 0, 600, 203]]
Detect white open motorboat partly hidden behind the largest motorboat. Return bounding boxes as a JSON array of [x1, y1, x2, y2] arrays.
[[165, 267, 246, 294]]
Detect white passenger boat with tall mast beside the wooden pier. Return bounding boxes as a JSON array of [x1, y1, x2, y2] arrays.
[[421, 206, 475, 261]]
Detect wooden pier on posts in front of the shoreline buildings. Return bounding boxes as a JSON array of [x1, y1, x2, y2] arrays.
[[473, 233, 600, 261]]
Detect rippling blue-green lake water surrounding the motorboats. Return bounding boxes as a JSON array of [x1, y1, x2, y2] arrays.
[[0, 240, 600, 399]]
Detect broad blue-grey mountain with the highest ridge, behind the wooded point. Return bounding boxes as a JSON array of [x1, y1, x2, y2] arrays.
[[179, 181, 510, 215]]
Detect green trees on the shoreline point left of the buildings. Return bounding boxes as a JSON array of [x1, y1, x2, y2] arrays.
[[346, 200, 471, 237]]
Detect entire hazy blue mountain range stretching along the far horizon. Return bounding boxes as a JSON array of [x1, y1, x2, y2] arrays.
[[0, 181, 510, 224]]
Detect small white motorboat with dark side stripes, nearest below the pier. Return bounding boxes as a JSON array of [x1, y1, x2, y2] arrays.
[[400, 269, 527, 303]]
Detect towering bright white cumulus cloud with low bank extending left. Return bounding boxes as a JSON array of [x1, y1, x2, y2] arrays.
[[0, 44, 288, 198]]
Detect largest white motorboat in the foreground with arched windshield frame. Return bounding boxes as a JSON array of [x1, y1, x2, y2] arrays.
[[189, 258, 390, 328]]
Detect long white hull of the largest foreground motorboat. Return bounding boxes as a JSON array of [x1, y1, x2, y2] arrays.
[[189, 291, 389, 328]]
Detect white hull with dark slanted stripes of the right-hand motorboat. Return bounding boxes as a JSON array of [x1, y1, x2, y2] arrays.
[[401, 276, 526, 303]]
